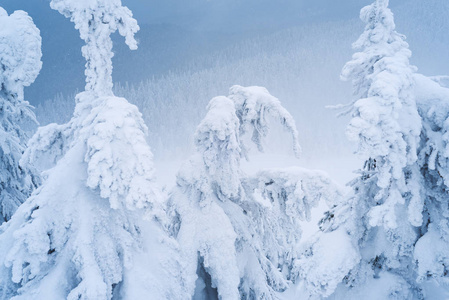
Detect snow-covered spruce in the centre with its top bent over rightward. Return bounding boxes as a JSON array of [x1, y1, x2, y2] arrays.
[[171, 86, 340, 300]]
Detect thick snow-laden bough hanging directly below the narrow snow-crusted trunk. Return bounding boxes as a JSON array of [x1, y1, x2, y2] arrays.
[[80, 97, 164, 214]]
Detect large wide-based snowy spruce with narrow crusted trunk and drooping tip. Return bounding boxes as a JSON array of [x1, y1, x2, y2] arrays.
[[0, 0, 185, 300]]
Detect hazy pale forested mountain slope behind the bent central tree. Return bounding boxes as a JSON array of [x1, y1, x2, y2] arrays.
[[38, 21, 361, 164]]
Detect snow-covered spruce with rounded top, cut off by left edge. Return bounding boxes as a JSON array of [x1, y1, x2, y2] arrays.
[[0, 7, 42, 224]]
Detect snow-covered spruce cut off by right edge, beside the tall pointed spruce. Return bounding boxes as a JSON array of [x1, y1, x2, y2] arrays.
[[414, 74, 449, 292]]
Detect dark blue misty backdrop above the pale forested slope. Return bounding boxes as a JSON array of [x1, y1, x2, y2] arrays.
[[0, 0, 426, 104]]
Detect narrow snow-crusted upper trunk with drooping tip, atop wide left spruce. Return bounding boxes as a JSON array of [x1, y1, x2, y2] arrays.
[[50, 0, 139, 96]]
